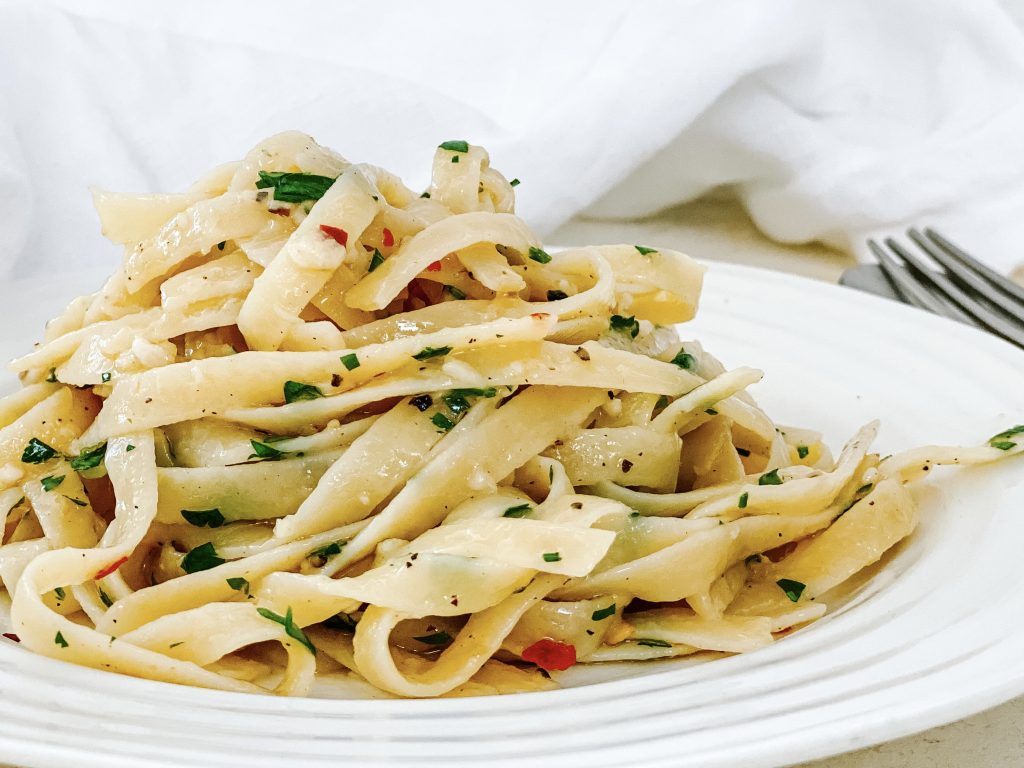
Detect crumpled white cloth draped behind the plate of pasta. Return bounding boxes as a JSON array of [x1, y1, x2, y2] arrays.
[[0, 0, 1024, 276]]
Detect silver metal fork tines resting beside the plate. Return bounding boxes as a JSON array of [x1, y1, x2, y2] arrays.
[[867, 228, 1024, 348]]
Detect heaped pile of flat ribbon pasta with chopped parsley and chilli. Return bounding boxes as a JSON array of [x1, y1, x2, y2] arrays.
[[0, 132, 1024, 696]]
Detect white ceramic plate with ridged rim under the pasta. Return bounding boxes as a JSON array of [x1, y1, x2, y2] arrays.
[[0, 264, 1024, 768]]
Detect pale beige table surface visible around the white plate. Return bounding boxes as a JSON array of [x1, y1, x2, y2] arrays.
[[549, 198, 1024, 768]]
